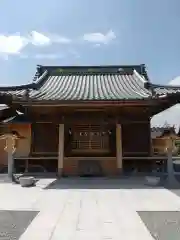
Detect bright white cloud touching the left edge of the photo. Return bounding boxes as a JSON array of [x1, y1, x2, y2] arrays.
[[0, 35, 28, 54]]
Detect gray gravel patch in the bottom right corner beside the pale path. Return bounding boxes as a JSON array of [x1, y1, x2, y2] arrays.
[[138, 211, 180, 240]]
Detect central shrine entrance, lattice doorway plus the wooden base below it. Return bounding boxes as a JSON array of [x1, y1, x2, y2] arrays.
[[64, 123, 116, 177]]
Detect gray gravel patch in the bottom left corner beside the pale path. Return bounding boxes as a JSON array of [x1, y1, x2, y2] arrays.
[[0, 211, 38, 240]]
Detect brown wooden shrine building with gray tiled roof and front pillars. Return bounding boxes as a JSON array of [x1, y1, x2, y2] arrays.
[[0, 64, 180, 176]]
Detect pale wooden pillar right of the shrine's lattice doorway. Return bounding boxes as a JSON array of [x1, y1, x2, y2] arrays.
[[116, 124, 123, 173]]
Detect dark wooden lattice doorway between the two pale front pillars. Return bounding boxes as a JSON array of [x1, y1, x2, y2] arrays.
[[66, 124, 115, 157]]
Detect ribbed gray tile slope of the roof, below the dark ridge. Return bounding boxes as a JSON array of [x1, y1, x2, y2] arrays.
[[30, 68, 151, 100]]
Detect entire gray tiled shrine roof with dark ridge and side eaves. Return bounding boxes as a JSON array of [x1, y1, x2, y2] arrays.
[[0, 65, 180, 101]]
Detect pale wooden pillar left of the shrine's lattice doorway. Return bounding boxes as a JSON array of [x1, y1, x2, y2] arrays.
[[58, 124, 64, 176]]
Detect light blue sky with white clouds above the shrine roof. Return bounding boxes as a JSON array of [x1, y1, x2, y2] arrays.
[[0, 0, 180, 85]]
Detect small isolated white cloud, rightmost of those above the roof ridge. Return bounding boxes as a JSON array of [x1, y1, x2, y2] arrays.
[[83, 30, 116, 44]]
